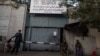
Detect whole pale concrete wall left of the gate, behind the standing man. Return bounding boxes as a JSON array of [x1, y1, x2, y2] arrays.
[[0, 5, 27, 49]]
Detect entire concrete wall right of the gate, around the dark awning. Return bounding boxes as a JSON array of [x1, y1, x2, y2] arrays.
[[64, 19, 100, 56]]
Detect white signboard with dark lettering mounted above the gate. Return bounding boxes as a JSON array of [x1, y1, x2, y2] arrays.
[[30, 0, 66, 14]]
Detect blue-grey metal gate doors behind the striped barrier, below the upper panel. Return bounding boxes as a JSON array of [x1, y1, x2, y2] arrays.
[[27, 28, 60, 51]]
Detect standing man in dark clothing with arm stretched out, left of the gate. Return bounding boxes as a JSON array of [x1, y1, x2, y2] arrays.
[[11, 30, 22, 54]]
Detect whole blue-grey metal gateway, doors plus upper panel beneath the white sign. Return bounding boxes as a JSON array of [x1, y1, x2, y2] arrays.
[[25, 14, 68, 51]]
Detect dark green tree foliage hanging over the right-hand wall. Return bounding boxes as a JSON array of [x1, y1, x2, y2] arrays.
[[65, 0, 100, 28]]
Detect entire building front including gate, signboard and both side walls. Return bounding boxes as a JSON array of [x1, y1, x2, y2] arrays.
[[0, 0, 100, 55]]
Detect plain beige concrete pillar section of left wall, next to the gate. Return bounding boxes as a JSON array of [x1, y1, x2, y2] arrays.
[[7, 5, 26, 38]]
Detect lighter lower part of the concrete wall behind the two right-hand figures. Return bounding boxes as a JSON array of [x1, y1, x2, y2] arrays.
[[64, 30, 96, 55]]
